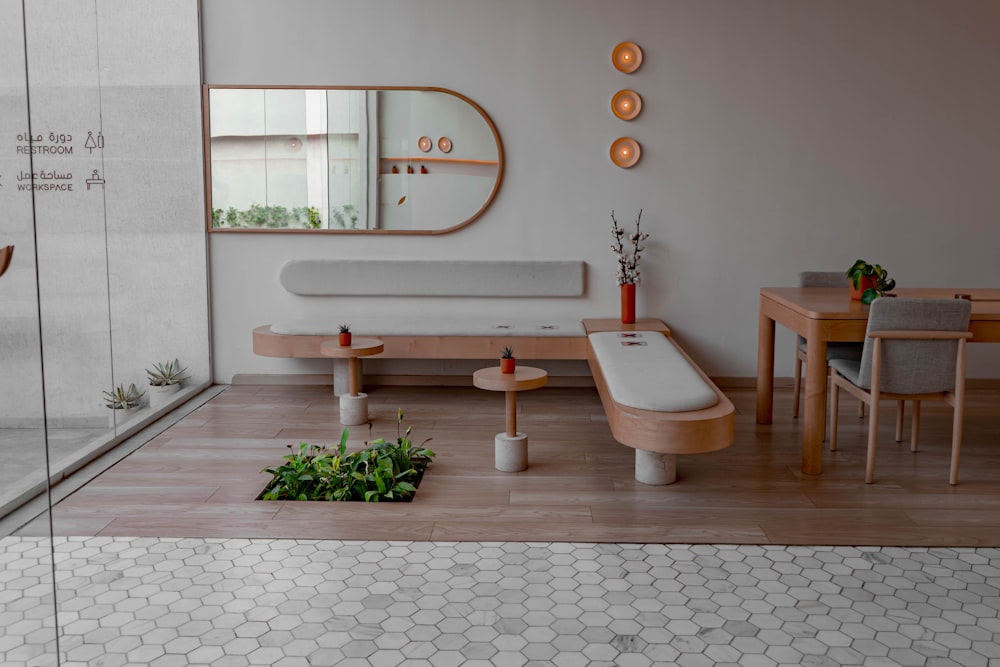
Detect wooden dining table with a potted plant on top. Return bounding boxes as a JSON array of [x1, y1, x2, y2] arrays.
[[757, 286, 1000, 475]]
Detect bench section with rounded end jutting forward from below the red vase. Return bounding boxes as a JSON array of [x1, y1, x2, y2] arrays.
[[584, 320, 735, 484]]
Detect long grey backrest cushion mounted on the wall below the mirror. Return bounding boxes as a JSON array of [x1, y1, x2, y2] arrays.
[[279, 259, 584, 297]]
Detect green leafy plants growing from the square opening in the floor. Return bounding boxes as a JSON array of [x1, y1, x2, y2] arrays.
[[261, 410, 434, 502]]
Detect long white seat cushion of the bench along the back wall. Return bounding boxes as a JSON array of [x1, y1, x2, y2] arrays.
[[271, 316, 587, 338]]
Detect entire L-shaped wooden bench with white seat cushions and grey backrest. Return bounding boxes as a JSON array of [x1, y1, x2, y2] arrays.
[[253, 259, 734, 484]]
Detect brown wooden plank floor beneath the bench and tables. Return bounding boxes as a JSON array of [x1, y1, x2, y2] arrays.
[[26, 386, 1000, 546]]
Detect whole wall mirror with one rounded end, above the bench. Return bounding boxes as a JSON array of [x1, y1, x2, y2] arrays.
[[204, 86, 503, 234]]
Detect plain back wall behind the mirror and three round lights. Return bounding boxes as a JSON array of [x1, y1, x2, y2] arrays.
[[203, 0, 1000, 382]]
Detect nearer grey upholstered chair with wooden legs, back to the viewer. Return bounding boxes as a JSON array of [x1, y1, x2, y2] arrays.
[[830, 297, 972, 484]]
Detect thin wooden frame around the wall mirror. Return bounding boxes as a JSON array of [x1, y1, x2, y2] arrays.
[[202, 84, 505, 235]]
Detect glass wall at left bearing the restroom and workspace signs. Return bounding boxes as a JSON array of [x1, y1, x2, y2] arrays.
[[0, 0, 211, 665]]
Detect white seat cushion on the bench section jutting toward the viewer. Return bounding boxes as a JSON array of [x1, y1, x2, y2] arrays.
[[590, 331, 719, 412]]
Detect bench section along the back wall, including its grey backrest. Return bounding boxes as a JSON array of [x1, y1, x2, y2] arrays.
[[253, 259, 587, 394]]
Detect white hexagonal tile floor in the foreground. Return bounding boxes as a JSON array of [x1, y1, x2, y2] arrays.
[[0, 537, 1000, 667]]
